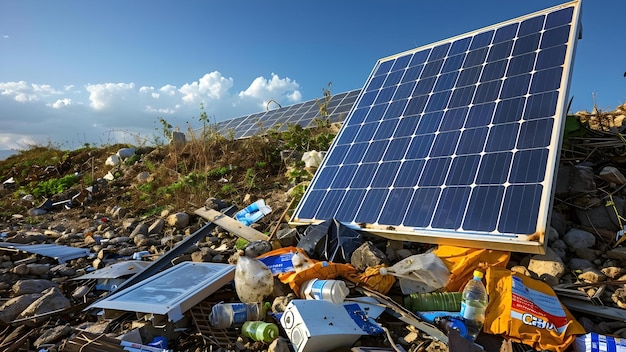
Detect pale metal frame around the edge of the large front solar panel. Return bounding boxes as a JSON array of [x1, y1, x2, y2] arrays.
[[289, 1, 582, 254]]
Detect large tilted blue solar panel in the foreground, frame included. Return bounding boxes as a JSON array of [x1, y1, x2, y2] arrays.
[[290, 1, 580, 253]]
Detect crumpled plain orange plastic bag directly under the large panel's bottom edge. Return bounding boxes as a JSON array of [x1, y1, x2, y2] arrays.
[[433, 245, 511, 292]]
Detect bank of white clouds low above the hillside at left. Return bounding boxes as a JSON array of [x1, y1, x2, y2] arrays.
[[0, 71, 302, 150]]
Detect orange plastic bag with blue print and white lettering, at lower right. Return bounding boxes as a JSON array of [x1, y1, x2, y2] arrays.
[[483, 267, 585, 352]]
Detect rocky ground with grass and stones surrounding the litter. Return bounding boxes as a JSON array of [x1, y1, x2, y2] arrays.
[[0, 106, 626, 351]]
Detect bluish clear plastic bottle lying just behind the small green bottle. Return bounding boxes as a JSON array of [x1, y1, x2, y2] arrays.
[[209, 303, 264, 329]]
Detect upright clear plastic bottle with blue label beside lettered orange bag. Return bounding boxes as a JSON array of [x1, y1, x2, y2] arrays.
[[460, 270, 489, 341]]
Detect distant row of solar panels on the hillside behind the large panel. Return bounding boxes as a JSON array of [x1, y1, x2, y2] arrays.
[[210, 89, 361, 139]]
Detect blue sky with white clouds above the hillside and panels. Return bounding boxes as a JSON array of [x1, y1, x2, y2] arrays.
[[0, 0, 626, 150]]
